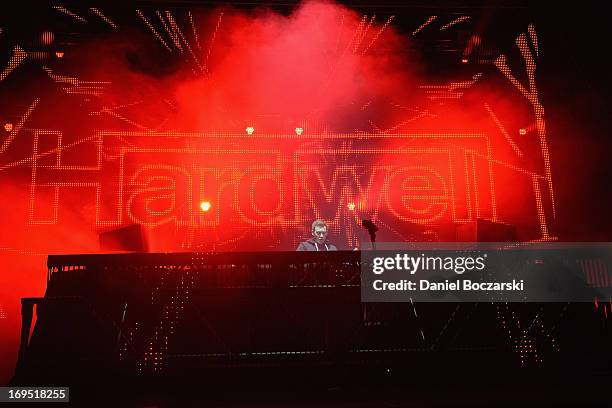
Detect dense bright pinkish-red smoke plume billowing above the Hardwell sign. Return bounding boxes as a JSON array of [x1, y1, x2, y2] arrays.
[[176, 2, 416, 131]]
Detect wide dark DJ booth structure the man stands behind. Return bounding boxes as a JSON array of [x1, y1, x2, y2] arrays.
[[13, 251, 612, 404]]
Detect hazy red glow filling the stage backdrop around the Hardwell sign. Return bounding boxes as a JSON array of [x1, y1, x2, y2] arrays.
[[0, 2, 554, 382]]
